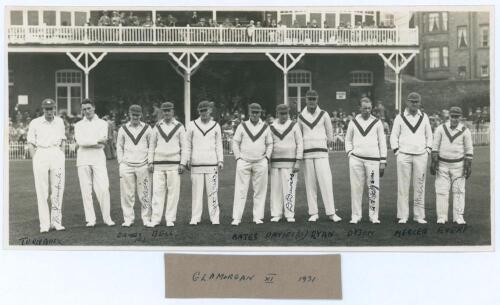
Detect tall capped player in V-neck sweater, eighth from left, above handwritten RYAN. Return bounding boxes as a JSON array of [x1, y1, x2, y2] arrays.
[[298, 90, 342, 222]]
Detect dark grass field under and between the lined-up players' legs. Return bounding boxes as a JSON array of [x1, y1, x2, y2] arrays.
[[9, 147, 491, 247]]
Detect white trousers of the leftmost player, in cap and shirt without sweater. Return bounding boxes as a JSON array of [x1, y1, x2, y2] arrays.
[[33, 147, 65, 230]]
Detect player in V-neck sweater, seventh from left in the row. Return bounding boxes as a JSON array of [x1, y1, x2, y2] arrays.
[[269, 104, 303, 222]]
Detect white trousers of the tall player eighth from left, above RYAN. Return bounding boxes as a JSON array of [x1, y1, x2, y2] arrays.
[[304, 158, 335, 216]]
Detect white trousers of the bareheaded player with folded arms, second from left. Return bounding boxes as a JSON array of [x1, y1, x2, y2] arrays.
[[78, 165, 112, 223]]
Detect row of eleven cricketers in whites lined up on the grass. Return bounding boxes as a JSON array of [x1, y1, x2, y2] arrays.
[[28, 90, 473, 232]]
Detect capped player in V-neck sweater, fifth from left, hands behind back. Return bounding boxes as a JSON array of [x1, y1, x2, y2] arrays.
[[186, 101, 224, 225]]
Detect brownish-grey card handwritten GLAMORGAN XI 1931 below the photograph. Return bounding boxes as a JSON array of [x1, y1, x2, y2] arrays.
[[165, 254, 342, 299]]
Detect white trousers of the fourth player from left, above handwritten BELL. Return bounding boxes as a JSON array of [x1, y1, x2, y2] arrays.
[[151, 167, 181, 224]]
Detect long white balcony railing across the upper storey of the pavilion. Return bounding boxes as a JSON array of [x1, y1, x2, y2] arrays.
[[7, 26, 418, 46]]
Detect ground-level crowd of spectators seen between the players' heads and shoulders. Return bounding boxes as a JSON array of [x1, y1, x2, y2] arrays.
[[9, 101, 490, 159]]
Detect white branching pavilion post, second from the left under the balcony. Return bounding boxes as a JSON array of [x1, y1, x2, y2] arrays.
[[168, 52, 208, 124]]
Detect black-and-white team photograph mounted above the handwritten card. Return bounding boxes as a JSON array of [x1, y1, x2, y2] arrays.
[[4, 6, 494, 247]]
